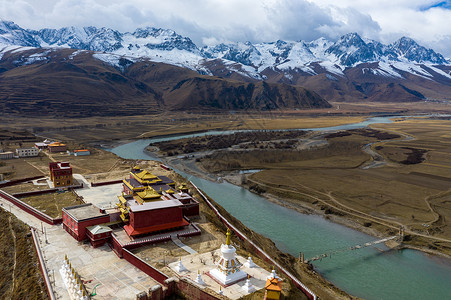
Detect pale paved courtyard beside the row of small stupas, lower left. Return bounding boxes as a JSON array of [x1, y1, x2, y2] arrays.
[[0, 191, 157, 300]]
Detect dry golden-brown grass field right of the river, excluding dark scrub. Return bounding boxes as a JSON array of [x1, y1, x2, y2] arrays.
[[237, 119, 451, 246]]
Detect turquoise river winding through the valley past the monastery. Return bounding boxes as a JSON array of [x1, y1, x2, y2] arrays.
[[109, 117, 451, 300]]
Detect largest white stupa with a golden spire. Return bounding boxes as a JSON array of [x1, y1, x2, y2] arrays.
[[210, 229, 247, 286]]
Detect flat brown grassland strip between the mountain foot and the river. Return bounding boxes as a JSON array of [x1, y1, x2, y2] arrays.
[[0, 110, 364, 145]]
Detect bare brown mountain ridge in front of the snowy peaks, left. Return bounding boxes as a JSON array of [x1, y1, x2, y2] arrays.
[[0, 48, 330, 117]]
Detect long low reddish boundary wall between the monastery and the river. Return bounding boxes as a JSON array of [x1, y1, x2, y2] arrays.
[[190, 181, 317, 300]]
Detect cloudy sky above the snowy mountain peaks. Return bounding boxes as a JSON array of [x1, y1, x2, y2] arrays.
[[0, 0, 451, 57]]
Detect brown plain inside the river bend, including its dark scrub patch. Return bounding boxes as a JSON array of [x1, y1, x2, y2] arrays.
[[201, 118, 451, 254]]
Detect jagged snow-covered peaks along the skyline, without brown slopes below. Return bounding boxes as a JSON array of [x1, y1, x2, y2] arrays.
[[0, 21, 451, 80]]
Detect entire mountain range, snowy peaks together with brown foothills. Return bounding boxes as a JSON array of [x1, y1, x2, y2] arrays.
[[0, 21, 451, 109]]
